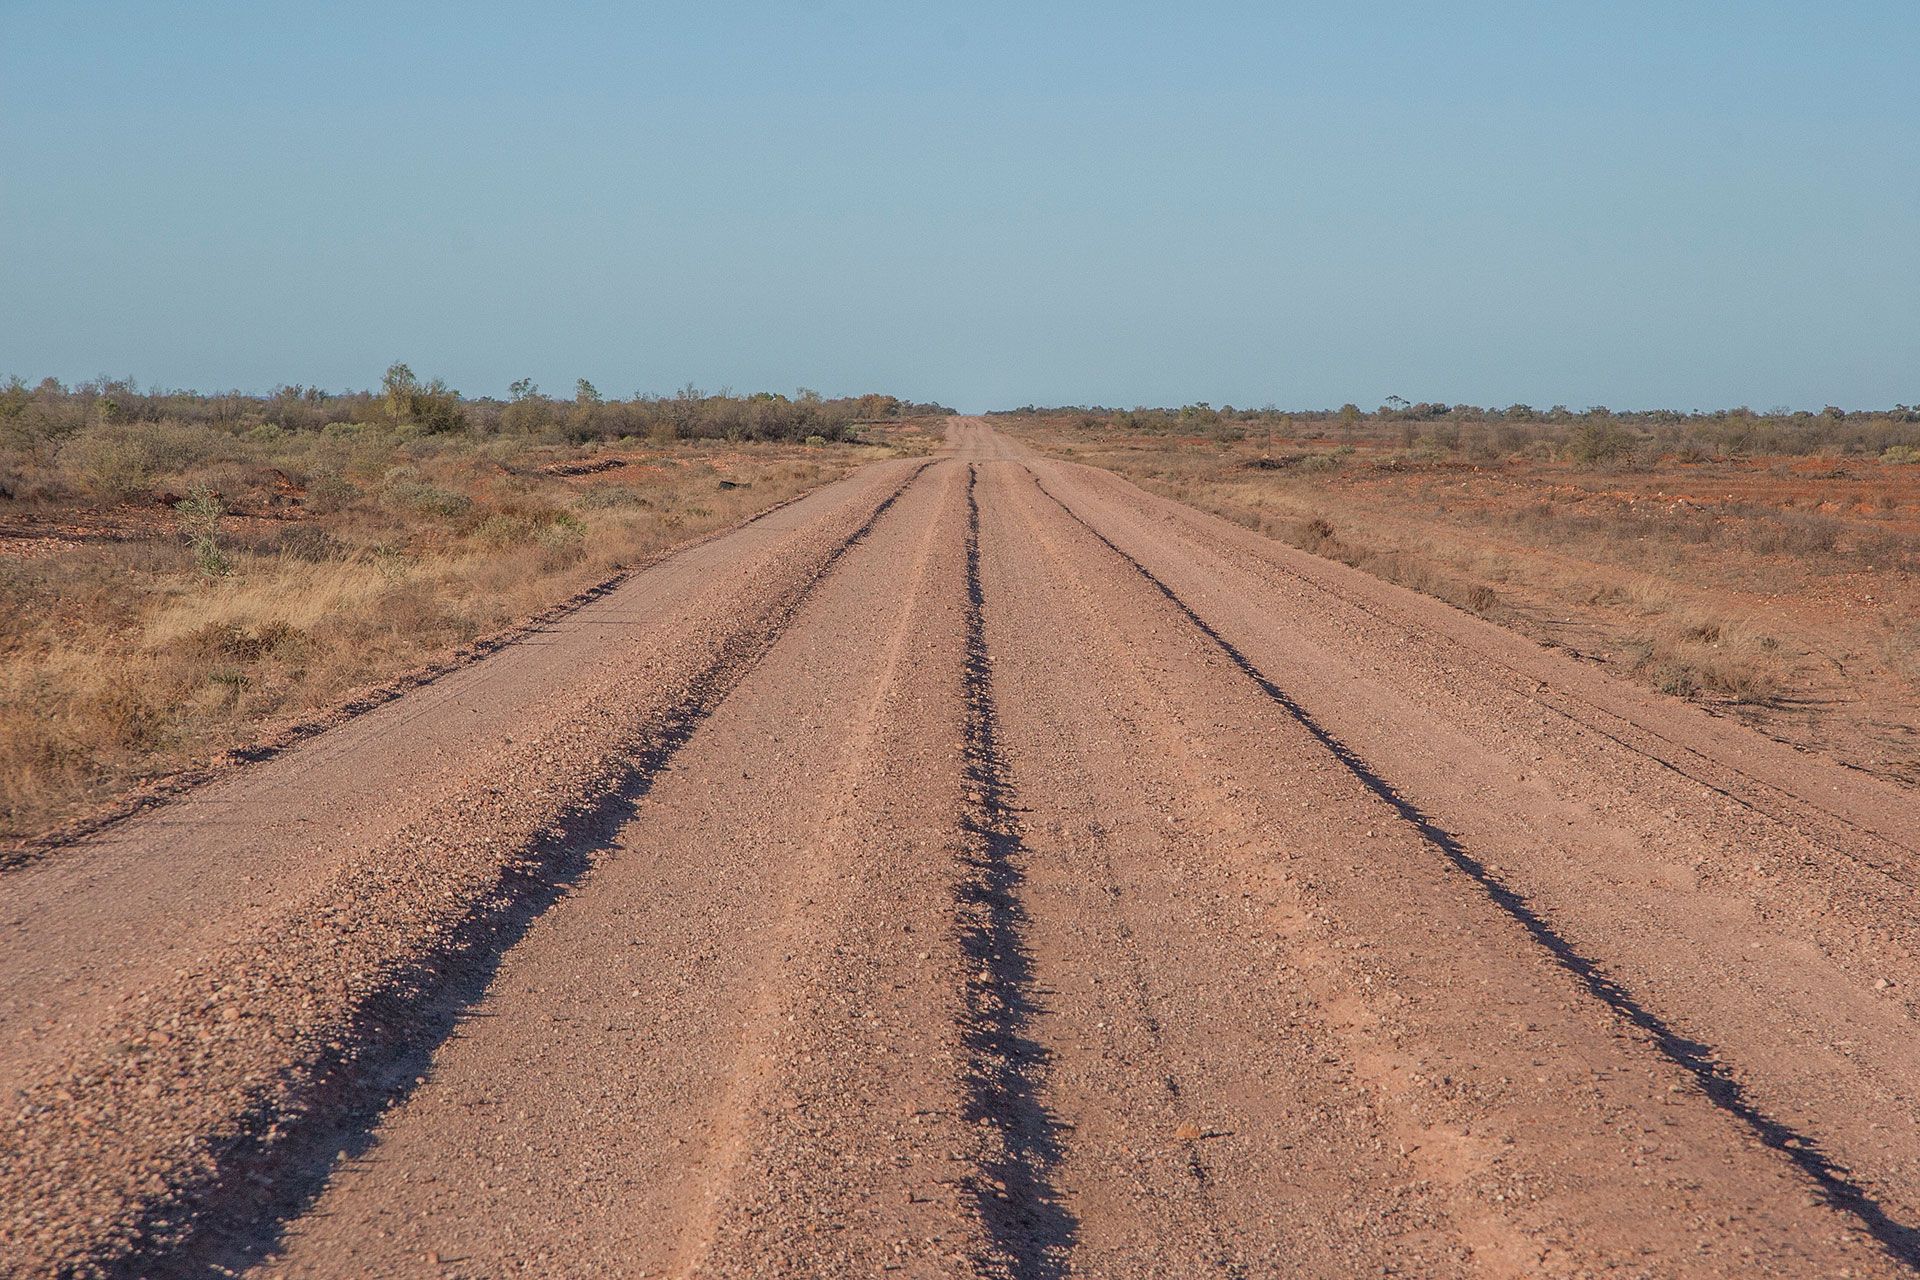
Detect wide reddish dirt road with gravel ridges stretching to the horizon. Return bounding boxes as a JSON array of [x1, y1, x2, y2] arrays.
[[0, 418, 1920, 1278]]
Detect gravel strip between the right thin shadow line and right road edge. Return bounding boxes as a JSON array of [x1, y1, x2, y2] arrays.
[[1035, 443, 1920, 1258]]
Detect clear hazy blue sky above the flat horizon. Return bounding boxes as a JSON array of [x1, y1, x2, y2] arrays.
[[0, 0, 1920, 409]]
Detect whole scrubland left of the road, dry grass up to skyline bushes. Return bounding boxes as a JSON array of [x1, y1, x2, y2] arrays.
[[0, 365, 945, 842]]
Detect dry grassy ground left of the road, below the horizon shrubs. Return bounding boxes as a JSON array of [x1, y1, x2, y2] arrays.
[[0, 424, 937, 839]]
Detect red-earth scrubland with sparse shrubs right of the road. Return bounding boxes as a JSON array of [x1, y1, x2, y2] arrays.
[[995, 401, 1920, 783]]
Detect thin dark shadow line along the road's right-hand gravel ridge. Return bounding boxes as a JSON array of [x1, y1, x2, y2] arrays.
[[1029, 468, 1920, 1268]]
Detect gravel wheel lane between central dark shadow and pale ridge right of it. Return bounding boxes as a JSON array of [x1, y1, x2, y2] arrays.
[[1000, 454, 1466, 1276]]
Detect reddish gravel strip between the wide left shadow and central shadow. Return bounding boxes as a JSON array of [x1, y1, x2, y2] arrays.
[[261, 462, 998, 1278]]
